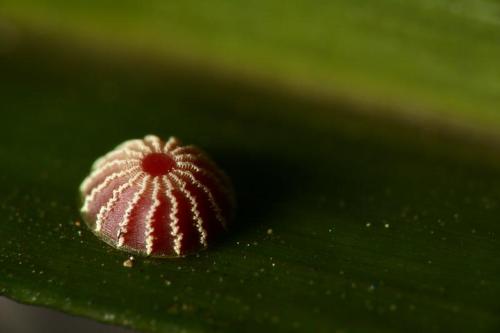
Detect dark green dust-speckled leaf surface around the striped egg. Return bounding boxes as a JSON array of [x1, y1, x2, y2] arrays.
[[0, 29, 500, 332]]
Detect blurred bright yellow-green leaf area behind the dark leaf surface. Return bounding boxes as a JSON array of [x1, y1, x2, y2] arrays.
[[0, 0, 500, 132]]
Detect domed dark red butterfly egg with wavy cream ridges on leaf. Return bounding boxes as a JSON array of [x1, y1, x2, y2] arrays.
[[80, 135, 234, 257]]
